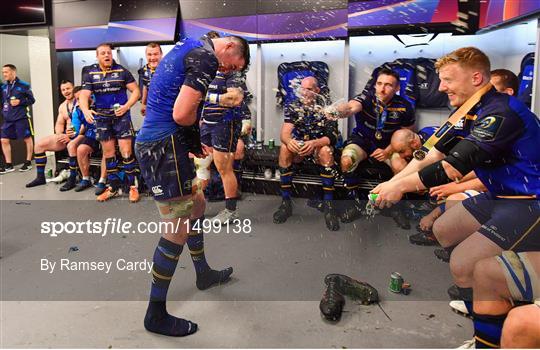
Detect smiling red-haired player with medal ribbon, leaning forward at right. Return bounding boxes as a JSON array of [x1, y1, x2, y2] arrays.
[[373, 47, 540, 348]]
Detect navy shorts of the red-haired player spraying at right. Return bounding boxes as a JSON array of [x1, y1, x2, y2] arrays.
[[462, 192, 540, 252]]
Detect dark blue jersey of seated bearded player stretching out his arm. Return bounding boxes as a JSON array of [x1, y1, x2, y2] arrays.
[[352, 92, 416, 148]]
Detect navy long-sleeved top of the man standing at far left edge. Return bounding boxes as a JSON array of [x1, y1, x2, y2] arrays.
[[2, 77, 36, 121]]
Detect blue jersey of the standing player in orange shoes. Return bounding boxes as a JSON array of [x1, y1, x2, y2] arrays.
[[82, 60, 135, 118]]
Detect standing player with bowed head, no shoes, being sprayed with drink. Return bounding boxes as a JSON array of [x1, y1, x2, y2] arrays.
[[135, 37, 249, 336]]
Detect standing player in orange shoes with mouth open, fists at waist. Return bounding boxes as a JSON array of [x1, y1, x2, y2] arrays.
[[79, 44, 140, 202]]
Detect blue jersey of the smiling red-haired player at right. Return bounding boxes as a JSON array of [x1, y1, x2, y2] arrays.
[[435, 89, 540, 197]]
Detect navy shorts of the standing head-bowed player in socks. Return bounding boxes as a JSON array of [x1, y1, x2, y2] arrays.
[[135, 131, 195, 201]]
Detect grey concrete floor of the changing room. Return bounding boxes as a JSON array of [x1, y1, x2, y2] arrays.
[[0, 166, 472, 348]]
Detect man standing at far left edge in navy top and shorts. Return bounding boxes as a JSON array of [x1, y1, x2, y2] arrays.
[[0, 64, 36, 174]]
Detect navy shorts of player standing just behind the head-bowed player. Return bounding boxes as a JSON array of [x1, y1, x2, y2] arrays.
[[201, 119, 242, 153]]
